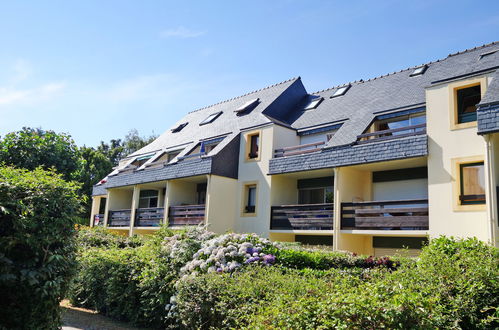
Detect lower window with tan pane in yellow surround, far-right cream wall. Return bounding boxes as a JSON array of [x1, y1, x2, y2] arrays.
[[459, 162, 485, 205]]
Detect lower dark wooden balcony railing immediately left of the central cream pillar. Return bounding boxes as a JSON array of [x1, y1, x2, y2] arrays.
[[270, 203, 333, 230]]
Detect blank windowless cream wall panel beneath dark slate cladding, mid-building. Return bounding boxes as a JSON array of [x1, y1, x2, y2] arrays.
[[206, 175, 239, 233]]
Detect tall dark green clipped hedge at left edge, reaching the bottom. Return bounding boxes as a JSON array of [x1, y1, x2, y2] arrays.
[[0, 167, 80, 329]]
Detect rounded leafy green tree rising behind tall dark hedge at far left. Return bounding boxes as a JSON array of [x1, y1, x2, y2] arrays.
[[0, 127, 79, 180]]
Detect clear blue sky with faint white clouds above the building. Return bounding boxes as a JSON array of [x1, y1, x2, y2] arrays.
[[0, 0, 499, 146]]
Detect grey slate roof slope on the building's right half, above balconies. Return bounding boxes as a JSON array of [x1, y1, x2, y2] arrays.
[[287, 42, 499, 146]]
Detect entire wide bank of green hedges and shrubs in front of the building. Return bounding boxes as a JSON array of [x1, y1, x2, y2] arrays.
[[70, 228, 499, 329]]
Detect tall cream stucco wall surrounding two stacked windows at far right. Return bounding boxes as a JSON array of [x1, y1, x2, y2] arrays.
[[426, 77, 488, 241]]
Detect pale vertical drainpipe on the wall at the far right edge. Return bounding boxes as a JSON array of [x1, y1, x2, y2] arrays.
[[483, 134, 497, 246]]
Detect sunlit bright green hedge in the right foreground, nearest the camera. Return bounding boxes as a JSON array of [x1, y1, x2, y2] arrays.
[[176, 238, 499, 329]]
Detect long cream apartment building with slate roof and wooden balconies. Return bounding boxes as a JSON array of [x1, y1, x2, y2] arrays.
[[91, 43, 499, 255]]
